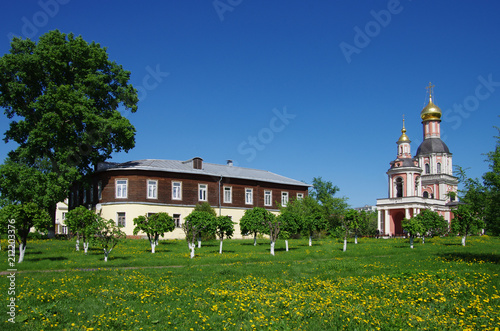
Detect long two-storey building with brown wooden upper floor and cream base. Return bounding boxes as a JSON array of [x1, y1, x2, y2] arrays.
[[70, 157, 310, 239]]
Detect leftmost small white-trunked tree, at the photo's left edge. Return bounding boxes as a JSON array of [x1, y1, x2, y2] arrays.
[[0, 202, 50, 263]]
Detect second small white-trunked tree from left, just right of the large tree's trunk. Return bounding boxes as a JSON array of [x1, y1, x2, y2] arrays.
[[64, 206, 99, 255]]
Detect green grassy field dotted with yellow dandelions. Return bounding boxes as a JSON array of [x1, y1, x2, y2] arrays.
[[0, 236, 500, 330]]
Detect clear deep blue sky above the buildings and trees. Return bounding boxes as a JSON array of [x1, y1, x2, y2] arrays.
[[0, 0, 500, 207]]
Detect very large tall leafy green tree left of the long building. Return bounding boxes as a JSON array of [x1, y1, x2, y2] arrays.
[[0, 30, 138, 233]]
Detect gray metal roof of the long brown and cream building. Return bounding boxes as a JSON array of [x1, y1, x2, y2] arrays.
[[97, 159, 311, 187]]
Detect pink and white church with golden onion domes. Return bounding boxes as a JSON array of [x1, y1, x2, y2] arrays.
[[377, 83, 458, 236]]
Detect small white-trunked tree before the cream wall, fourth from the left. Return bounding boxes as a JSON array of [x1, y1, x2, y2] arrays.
[[133, 212, 175, 253]]
